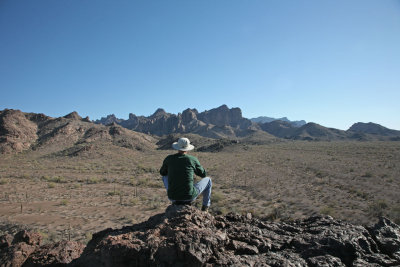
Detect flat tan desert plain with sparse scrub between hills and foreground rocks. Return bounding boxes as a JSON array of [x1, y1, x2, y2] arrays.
[[0, 141, 400, 245]]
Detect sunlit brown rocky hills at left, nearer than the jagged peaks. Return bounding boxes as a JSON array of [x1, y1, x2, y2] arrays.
[[0, 109, 157, 156]]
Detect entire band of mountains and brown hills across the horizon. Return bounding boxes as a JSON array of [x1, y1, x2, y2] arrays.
[[0, 105, 400, 155]]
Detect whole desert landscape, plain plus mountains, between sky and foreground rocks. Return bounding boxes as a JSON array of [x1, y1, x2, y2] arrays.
[[0, 106, 400, 246]]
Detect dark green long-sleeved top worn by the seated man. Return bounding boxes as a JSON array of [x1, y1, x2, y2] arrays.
[[160, 153, 207, 200]]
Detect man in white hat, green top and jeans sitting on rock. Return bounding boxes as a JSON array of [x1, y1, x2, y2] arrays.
[[160, 138, 212, 211]]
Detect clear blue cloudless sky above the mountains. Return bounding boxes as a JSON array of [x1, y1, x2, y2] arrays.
[[0, 0, 400, 130]]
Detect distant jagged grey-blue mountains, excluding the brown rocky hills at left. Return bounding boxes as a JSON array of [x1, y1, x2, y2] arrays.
[[95, 105, 400, 141]]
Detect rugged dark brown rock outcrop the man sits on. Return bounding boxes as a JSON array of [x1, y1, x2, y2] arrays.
[[0, 206, 400, 266]]
